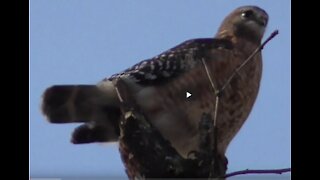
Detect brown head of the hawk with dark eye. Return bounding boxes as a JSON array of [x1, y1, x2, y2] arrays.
[[217, 6, 268, 43]]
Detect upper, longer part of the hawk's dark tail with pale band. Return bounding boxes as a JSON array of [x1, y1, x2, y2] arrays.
[[42, 85, 115, 123]]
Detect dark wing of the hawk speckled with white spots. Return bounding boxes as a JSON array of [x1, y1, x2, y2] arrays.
[[108, 38, 232, 85]]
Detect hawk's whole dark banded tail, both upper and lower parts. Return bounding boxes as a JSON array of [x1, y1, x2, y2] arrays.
[[42, 85, 121, 144]]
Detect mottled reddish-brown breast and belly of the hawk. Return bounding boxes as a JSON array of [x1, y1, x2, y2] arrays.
[[137, 50, 261, 156]]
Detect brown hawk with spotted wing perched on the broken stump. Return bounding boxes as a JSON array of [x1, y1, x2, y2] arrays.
[[42, 6, 268, 157]]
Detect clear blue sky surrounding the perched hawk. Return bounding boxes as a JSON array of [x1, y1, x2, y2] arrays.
[[30, 0, 291, 177]]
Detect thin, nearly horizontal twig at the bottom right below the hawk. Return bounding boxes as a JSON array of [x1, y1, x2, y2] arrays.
[[224, 168, 291, 178]]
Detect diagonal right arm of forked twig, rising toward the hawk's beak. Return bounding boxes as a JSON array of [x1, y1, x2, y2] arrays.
[[220, 30, 279, 92]]
